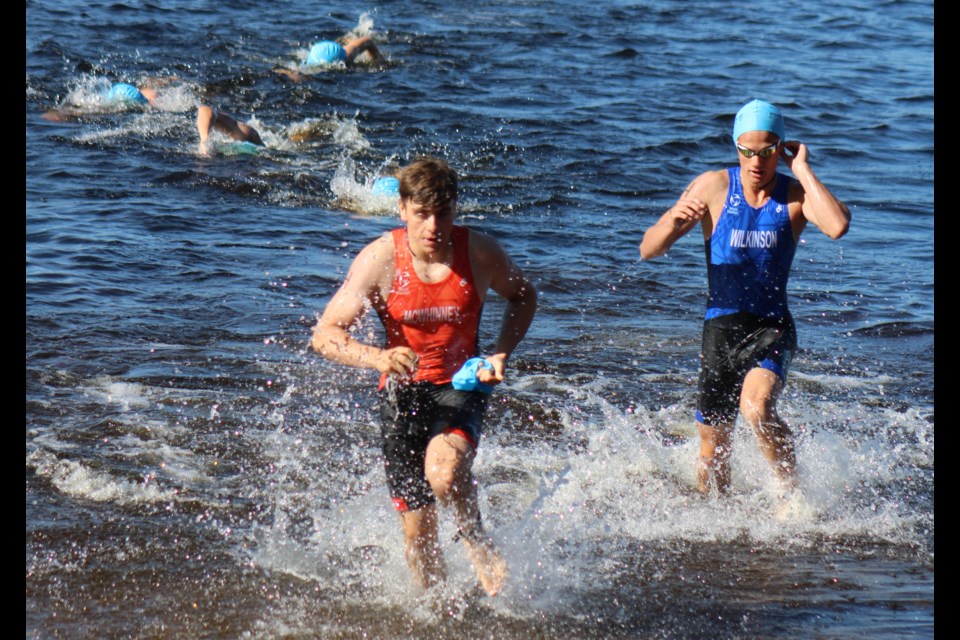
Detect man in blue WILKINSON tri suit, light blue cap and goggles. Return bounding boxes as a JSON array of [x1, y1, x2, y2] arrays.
[[640, 100, 850, 493]]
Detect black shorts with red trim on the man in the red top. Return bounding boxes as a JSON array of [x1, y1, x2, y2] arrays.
[[380, 382, 489, 511]]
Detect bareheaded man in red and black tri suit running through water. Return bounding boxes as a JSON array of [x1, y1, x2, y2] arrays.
[[311, 157, 537, 596]]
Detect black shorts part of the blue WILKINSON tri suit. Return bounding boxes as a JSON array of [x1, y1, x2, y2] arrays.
[[697, 313, 797, 426]]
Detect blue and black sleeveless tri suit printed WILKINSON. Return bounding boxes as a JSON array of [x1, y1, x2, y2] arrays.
[[697, 167, 797, 426]]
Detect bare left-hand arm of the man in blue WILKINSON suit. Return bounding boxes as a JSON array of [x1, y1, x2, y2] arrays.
[[640, 171, 727, 260]]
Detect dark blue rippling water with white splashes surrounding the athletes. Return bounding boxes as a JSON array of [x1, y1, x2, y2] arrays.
[[25, 0, 935, 638]]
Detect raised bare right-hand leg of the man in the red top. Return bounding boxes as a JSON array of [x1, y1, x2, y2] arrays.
[[425, 434, 507, 596]]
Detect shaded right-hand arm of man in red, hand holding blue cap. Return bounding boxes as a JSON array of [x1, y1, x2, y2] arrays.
[[470, 231, 537, 384]]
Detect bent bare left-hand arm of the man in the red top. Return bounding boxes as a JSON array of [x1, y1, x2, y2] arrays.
[[310, 234, 417, 375]]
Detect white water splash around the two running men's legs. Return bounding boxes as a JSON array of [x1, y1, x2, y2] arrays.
[[238, 368, 929, 617]]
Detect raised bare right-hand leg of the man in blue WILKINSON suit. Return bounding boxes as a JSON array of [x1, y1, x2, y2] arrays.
[[740, 368, 797, 489]]
